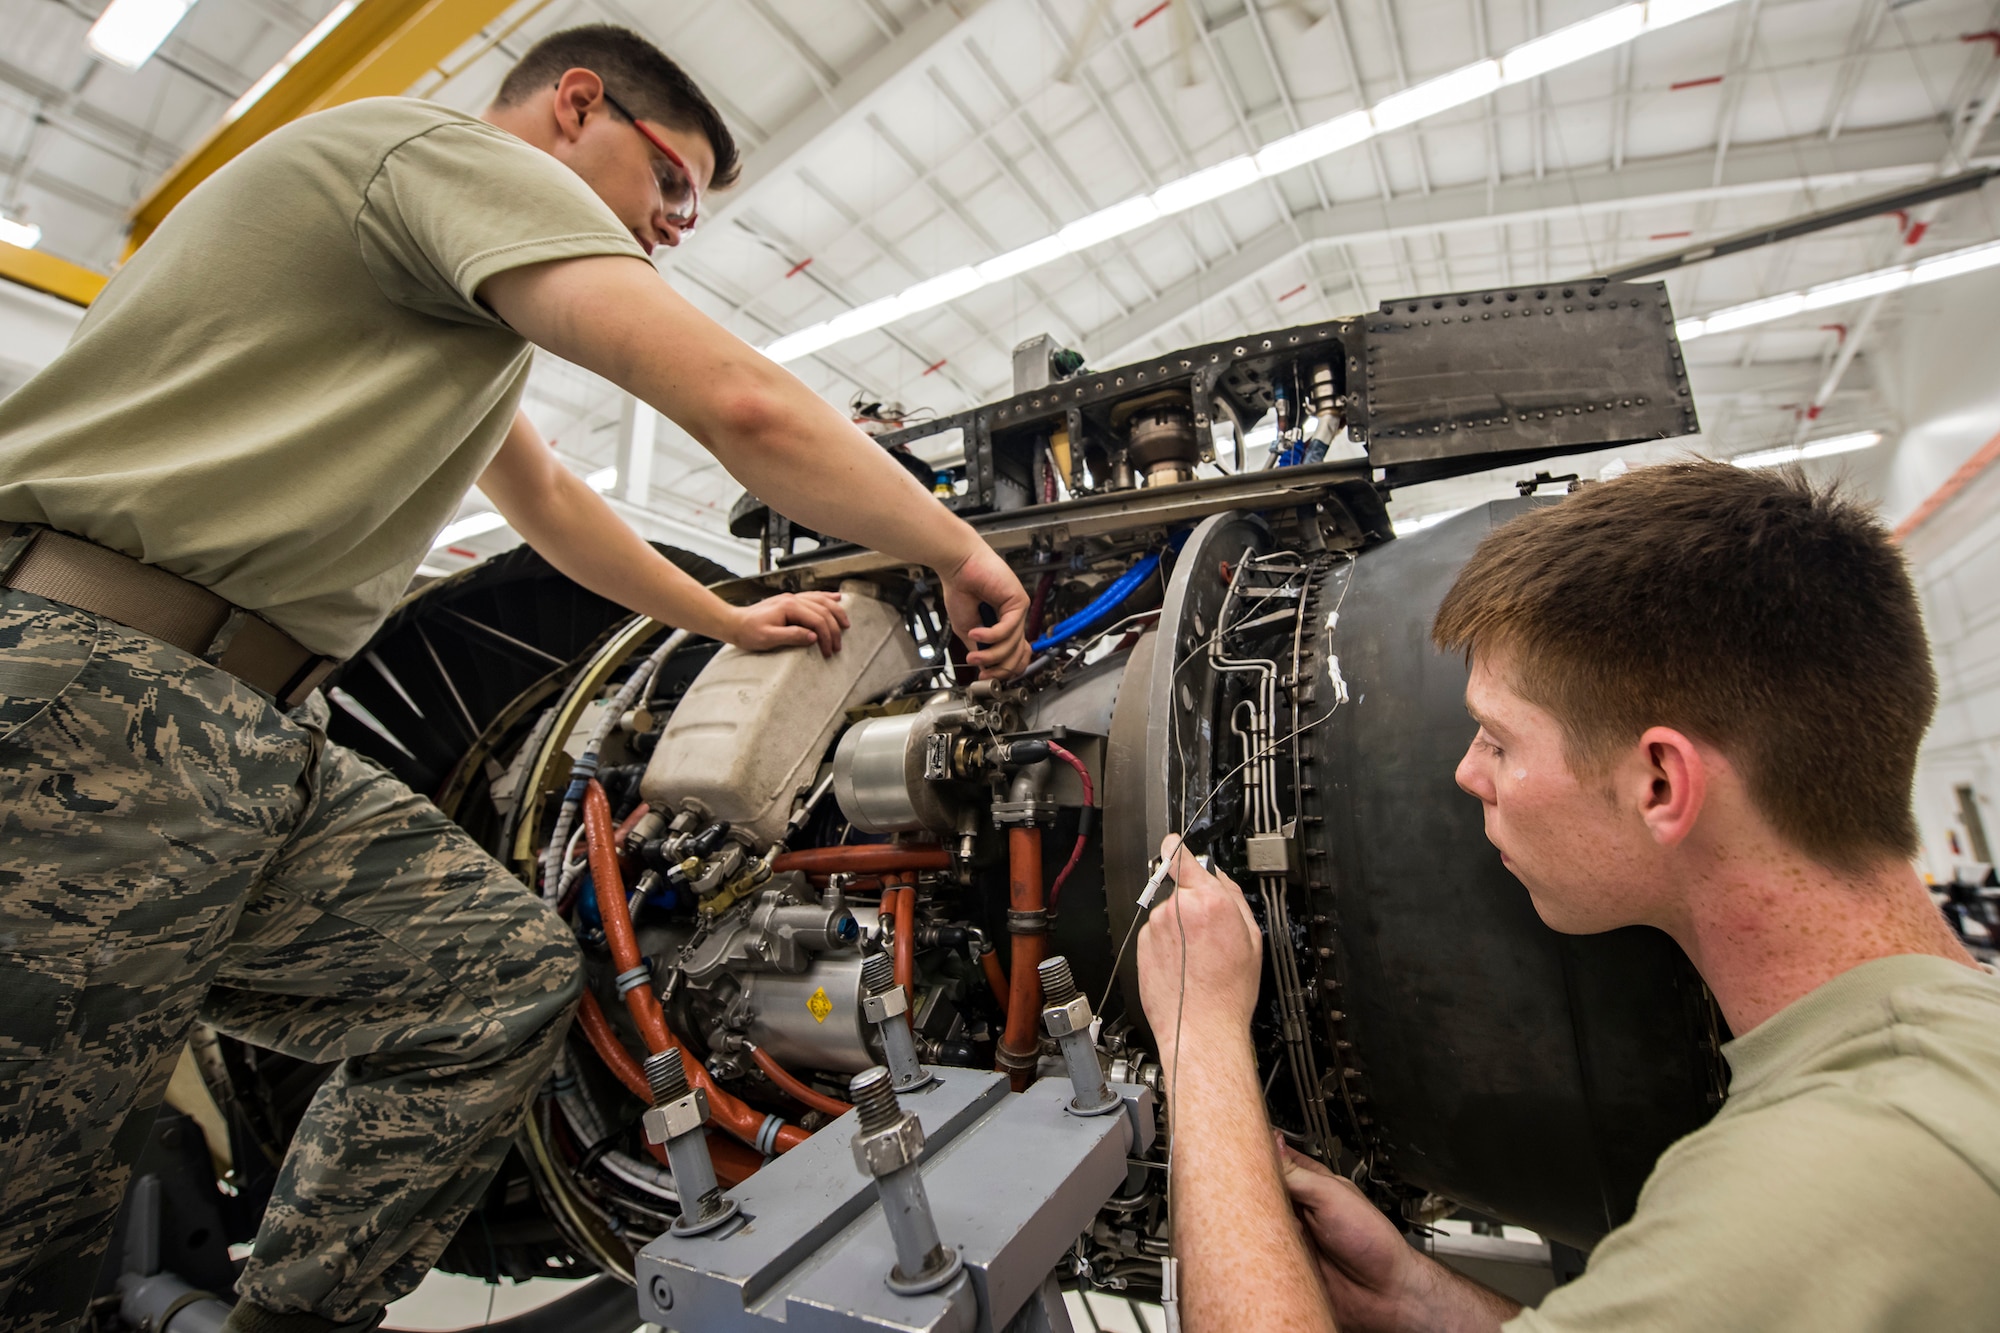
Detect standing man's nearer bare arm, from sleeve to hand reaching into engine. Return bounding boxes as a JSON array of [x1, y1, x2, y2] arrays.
[[480, 256, 1028, 675]]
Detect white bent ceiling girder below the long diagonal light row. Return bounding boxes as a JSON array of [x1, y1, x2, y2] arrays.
[[1084, 122, 1992, 364]]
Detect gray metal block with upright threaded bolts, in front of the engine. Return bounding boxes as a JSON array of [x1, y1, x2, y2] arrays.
[[638, 1069, 1152, 1333]]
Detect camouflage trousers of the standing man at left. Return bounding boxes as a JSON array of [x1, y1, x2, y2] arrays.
[[0, 592, 578, 1329]]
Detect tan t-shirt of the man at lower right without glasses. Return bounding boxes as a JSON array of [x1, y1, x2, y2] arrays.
[[1506, 955, 2000, 1333]]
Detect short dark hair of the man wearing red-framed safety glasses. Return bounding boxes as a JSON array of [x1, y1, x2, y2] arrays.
[[494, 24, 742, 190]]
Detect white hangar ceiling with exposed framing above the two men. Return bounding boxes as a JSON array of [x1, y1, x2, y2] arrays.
[[0, 0, 2000, 566]]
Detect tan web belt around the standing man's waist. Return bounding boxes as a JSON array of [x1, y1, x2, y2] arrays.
[[0, 522, 340, 709]]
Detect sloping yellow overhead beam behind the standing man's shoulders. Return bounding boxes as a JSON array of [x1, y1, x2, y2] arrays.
[[130, 0, 508, 246]]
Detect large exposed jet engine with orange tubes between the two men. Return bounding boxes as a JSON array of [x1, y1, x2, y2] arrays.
[[152, 282, 1720, 1327]]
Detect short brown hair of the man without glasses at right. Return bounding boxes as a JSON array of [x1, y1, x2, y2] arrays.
[[1432, 460, 1938, 871]]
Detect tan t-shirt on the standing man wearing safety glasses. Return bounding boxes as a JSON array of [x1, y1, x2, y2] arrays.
[[0, 98, 644, 656]]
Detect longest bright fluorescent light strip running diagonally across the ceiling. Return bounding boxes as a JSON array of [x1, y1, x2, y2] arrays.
[[764, 0, 1744, 362]]
